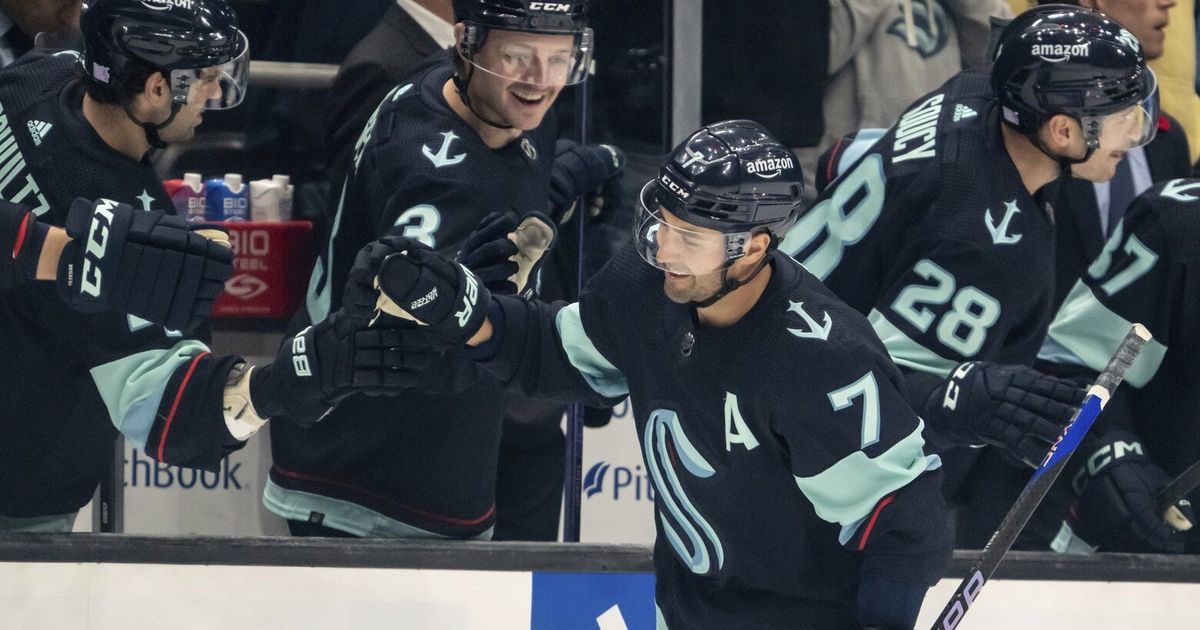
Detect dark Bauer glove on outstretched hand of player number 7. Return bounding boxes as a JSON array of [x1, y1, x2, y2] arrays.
[[360, 236, 492, 348]]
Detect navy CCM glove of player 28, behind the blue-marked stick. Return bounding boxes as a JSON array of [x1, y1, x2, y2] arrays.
[[922, 361, 1084, 468]]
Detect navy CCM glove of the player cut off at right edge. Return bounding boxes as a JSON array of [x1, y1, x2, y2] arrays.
[[1070, 431, 1195, 553]]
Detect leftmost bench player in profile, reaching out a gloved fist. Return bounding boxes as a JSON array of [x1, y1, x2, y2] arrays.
[[0, 0, 439, 530]]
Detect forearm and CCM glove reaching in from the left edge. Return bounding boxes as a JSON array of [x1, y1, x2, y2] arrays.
[[0, 199, 233, 330]]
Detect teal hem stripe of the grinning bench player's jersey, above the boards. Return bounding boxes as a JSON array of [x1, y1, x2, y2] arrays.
[[263, 479, 493, 540]]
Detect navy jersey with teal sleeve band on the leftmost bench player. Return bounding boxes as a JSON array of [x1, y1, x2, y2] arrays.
[[0, 52, 240, 516]]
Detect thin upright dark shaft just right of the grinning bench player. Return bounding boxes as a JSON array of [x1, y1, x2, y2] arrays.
[[563, 56, 595, 542]]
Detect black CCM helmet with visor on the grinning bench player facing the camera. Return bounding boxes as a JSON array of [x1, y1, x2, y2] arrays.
[[454, 0, 593, 85]]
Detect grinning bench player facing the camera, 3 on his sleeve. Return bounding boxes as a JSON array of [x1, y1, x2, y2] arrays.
[[263, 0, 612, 538]]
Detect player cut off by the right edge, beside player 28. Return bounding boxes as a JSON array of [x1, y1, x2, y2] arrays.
[[1030, 179, 1200, 553]]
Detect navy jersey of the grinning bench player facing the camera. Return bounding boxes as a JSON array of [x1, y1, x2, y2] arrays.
[[264, 53, 554, 538]]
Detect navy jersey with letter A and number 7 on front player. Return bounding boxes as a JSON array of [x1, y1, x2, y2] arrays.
[[482, 247, 949, 629]]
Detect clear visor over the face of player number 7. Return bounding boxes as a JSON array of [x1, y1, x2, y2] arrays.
[[634, 181, 750, 276]]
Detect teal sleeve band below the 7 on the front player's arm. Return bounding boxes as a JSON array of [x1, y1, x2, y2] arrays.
[[796, 421, 942, 544]]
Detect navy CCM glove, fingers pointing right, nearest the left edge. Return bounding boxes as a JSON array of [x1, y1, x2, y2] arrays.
[[58, 199, 233, 330]]
